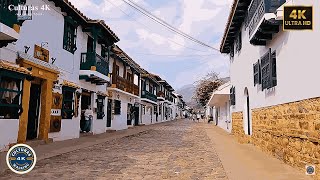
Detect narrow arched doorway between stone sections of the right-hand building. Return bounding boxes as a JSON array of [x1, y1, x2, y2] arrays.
[[243, 88, 252, 135]]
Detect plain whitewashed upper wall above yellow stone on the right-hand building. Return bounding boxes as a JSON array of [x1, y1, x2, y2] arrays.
[[230, 0, 320, 113]]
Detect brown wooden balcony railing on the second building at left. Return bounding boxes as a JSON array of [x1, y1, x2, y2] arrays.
[[112, 75, 139, 96]]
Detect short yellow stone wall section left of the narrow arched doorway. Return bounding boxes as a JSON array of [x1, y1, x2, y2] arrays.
[[232, 112, 251, 143]]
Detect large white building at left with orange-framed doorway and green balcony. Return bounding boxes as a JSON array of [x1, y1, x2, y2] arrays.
[[0, 0, 119, 149]]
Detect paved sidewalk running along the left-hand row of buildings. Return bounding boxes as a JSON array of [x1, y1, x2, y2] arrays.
[[0, 121, 172, 176]]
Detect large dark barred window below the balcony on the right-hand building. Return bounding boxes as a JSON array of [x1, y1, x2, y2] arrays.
[[261, 49, 277, 90]]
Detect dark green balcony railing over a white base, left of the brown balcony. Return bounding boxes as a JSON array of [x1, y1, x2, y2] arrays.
[[80, 52, 109, 76]]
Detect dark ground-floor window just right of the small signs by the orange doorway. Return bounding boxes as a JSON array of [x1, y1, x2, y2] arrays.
[[62, 87, 75, 119]]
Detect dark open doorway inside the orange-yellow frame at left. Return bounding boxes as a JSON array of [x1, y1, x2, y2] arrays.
[[27, 84, 41, 140]]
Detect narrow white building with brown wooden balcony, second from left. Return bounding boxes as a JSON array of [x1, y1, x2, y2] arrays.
[[107, 46, 143, 130]]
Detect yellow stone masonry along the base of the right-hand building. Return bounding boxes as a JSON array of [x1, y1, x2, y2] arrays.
[[252, 98, 320, 180]]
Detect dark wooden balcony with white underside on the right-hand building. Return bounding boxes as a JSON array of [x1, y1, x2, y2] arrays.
[[248, 0, 286, 46]]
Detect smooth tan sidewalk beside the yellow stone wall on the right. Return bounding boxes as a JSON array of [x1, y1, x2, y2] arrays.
[[201, 123, 312, 180]]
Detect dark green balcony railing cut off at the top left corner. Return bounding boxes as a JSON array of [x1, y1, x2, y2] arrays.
[[0, 0, 20, 28]]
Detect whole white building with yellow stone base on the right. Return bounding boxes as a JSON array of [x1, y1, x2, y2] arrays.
[[220, 0, 320, 174]]
